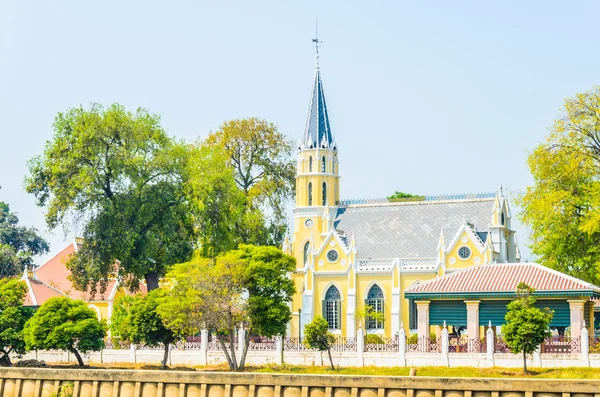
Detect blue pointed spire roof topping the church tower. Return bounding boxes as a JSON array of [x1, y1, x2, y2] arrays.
[[301, 54, 337, 150]]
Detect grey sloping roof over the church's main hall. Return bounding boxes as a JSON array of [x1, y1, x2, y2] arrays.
[[334, 198, 494, 259]]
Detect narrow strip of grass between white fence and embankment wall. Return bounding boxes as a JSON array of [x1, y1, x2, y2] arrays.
[[45, 363, 600, 379]]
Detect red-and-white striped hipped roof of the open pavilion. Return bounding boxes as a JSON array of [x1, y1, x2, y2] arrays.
[[404, 263, 600, 298]]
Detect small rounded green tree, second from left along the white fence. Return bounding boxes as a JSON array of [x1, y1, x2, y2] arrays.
[[23, 297, 107, 366]]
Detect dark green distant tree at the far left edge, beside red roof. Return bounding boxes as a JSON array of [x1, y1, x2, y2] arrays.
[[0, 197, 49, 278]]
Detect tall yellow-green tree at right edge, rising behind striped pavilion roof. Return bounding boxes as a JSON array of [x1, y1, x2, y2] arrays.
[[518, 87, 600, 284]]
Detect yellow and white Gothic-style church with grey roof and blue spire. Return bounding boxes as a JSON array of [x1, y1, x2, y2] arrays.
[[283, 46, 520, 337]]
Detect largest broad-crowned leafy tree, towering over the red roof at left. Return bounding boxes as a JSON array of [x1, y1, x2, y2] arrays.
[[26, 104, 196, 292]]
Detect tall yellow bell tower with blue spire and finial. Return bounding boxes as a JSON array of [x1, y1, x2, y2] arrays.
[[293, 39, 340, 268]]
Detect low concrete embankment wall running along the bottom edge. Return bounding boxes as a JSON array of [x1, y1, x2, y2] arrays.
[[0, 368, 600, 397]]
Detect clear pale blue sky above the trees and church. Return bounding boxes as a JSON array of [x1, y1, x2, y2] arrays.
[[0, 0, 600, 258]]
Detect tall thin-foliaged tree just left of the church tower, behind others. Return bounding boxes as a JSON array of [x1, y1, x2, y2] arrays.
[[207, 117, 296, 245]]
